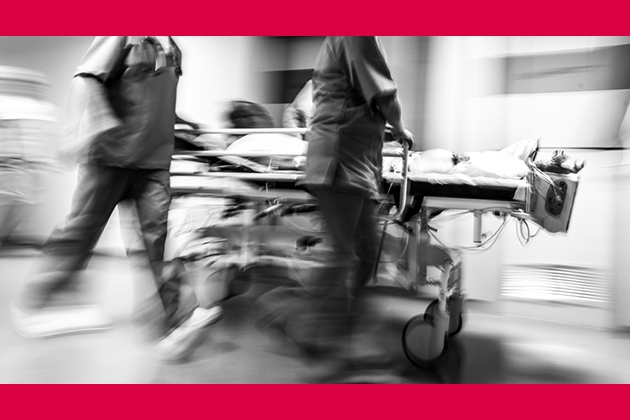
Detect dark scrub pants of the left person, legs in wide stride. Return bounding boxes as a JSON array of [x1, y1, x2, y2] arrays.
[[18, 164, 179, 324]]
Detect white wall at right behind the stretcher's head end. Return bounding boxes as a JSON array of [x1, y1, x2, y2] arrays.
[[424, 37, 630, 327]]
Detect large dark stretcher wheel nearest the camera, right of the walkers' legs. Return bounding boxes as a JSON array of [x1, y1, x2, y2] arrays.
[[402, 314, 448, 369]]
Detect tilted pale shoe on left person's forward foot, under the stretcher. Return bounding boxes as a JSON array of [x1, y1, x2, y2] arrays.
[[153, 306, 223, 362]]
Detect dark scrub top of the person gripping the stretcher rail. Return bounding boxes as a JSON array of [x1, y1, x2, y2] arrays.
[[304, 36, 397, 198]]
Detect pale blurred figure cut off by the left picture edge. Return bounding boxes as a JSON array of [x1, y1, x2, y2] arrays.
[[0, 67, 55, 248]]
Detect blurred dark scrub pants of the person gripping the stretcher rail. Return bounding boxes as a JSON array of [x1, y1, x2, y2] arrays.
[[257, 188, 379, 352]]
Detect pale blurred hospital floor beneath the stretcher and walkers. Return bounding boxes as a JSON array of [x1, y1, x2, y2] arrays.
[[0, 250, 630, 384]]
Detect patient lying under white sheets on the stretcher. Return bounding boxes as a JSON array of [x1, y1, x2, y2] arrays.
[[176, 100, 584, 182]]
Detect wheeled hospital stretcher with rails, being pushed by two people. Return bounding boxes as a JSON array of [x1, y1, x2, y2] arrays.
[[171, 129, 578, 367]]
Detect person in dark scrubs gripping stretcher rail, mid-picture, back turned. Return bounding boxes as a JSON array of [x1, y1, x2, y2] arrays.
[[256, 37, 413, 370]]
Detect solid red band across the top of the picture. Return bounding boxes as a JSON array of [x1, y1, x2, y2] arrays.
[[0, 0, 630, 36]]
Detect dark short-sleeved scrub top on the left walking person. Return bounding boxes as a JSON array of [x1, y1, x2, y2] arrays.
[[74, 36, 181, 169]]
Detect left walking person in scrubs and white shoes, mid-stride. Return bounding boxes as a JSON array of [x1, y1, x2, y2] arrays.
[[13, 37, 222, 359]]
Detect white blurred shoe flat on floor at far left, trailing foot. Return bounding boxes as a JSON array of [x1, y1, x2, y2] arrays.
[[11, 305, 113, 338]]
